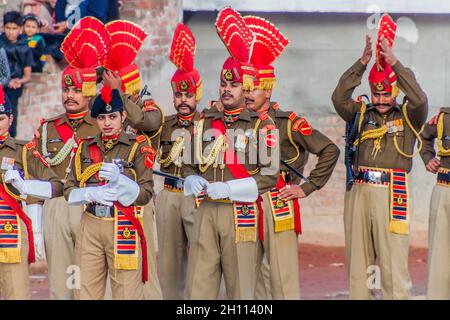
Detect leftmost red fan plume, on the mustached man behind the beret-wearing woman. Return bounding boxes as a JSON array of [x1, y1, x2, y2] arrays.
[[61, 17, 111, 69]]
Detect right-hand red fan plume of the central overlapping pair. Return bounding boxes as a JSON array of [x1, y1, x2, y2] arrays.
[[244, 16, 289, 65]]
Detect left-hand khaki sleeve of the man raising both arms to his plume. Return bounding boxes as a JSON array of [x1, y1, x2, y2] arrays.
[[331, 59, 367, 122]]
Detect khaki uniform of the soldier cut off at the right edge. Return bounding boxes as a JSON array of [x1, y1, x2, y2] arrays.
[[420, 108, 450, 300]]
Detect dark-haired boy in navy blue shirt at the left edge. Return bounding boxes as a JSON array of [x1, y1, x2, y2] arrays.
[[0, 11, 33, 137]]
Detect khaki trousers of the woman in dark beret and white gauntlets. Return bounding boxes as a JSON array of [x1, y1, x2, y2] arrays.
[[75, 212, 145, 300]]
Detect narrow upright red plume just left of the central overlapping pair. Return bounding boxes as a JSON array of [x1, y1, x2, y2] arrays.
[[169, 23, 196, 73]]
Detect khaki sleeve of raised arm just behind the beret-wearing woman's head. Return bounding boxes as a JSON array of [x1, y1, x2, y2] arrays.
[[122, 95, 164, 132]]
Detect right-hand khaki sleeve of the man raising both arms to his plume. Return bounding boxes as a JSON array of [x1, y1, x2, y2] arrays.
[[392, 61, 428, 129]]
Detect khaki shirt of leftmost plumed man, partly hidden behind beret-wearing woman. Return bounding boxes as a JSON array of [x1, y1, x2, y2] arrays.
[[35, 112, 100, 179]]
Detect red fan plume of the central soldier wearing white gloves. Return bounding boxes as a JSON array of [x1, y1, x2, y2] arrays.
[[216, 7, 255, 63]]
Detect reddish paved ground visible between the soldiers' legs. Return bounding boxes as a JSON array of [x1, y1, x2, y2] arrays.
[[22, 244, 427, 300]]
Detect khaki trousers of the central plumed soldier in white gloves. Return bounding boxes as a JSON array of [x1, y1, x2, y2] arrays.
[[186, 200, 261, 300]]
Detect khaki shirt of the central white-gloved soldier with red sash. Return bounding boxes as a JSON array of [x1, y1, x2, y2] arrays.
[[185, 109, 279, 194]]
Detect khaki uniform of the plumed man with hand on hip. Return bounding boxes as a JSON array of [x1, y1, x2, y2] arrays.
[[255, 104, 339, 299]]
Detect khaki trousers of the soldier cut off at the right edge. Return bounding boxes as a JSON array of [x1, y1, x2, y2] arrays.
[[427, 185, 450, 300]]
